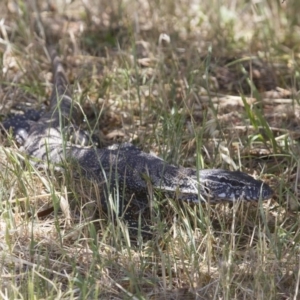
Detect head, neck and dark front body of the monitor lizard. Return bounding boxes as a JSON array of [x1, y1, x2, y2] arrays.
[[66, 143, 273, 203]]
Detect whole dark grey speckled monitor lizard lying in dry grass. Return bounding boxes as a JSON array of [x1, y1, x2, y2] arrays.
[[2, 50, 273, 211]]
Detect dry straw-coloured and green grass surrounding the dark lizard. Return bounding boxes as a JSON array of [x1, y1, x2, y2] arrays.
[[0, 0, 300, 299]]
